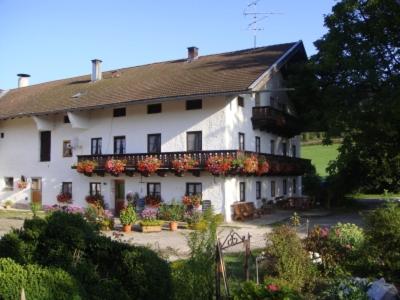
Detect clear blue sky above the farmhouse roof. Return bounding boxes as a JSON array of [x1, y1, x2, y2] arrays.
[[0, 0, 335, 89]]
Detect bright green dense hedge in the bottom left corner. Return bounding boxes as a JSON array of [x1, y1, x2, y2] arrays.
[[0, 258, 81, 300]]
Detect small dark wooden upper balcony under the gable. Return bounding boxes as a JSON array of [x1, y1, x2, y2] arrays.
[[251, 106, 302, 137]]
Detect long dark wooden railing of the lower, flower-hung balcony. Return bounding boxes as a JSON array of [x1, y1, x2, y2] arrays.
[[78, 150, 310, 176]]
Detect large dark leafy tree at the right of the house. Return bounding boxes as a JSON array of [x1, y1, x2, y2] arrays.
[[292, 0, 400, 192]]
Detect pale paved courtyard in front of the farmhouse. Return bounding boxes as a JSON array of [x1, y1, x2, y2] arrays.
[[0, 210, 363, 260]]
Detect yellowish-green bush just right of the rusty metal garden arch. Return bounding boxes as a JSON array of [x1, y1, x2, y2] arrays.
[[266, 226, 316, 291]]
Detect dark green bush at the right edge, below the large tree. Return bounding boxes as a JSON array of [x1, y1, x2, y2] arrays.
[[365, 203, 400, 281]]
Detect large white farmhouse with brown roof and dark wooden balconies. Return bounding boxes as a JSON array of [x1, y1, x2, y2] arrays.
[[0, 41, 307, 221]]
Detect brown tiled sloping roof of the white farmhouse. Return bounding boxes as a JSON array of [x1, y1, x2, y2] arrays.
[[0, 43, 295, 119]]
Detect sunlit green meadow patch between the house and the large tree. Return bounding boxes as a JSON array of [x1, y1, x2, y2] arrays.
[[301, 144, 339, 177]]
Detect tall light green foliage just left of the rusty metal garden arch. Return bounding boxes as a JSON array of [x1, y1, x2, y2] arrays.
[[172, 209, 219, 300]]
